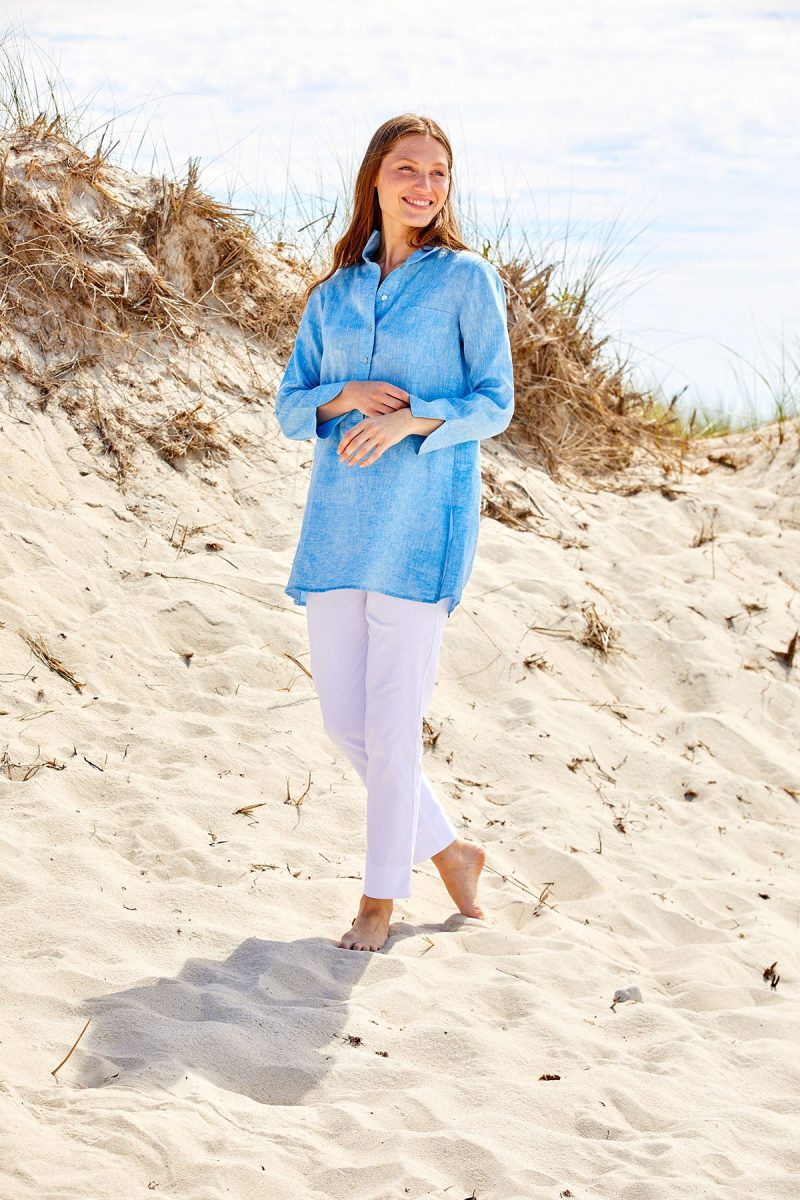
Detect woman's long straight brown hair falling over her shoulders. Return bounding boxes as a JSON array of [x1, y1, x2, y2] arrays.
[[303, 113, 470, 302]]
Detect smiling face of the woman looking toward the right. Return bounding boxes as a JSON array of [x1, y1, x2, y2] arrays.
[[375, 133, 450, 228]]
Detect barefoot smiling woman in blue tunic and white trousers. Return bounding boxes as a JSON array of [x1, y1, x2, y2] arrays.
[[276, 114, 513, 950]]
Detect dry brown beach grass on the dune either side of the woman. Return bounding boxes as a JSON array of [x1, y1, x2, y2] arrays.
[[0, 116, 688, 501]]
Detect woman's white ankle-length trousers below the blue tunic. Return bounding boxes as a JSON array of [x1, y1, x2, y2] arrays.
[[306, 588, 458, 900]]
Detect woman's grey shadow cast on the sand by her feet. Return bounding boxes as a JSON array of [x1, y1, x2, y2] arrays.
[[65, 923, 453, 1104]]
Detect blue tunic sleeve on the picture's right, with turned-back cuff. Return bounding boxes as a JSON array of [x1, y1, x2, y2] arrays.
[[409, 263, 513, 454]]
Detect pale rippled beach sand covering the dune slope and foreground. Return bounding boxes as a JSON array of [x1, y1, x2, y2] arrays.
[[0, 124, 800, 1200]]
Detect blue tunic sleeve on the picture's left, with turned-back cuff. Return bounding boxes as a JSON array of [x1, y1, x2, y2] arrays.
[[275, 287, 345, 438]]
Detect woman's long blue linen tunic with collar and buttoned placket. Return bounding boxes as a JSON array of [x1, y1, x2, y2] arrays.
[[275, 229, 513, 616]]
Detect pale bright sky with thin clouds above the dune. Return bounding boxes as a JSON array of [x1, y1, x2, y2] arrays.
[[0, 0, 800, 418]]
